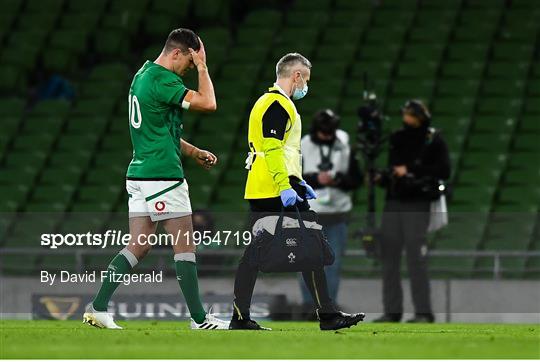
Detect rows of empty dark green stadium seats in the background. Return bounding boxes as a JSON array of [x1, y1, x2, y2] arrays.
[[0, 0, 540, 276]]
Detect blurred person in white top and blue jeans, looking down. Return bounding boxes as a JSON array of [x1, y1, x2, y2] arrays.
[[301, 109, 362, 304]]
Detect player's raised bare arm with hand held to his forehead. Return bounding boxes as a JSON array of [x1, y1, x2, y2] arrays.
[[182, 38, 217, 112]]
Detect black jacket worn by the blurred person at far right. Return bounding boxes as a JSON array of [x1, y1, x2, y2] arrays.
[[383, 125, 450, 201]]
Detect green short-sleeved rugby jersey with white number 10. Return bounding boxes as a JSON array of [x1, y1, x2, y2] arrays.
[[126, 61, 188, 180]]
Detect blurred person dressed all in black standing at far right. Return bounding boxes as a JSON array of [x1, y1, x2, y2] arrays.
[[375, 100, 450, 323]]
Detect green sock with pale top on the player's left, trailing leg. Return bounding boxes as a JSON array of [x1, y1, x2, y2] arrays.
[[92, 249, 138, 312]]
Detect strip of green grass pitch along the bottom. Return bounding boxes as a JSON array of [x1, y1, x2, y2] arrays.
[[0, 321, 540, 359]]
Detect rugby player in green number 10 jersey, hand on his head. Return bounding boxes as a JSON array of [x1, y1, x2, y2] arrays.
[[83, 29, 229, 329]]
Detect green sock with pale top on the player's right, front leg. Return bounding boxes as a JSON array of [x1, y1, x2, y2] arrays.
[[174, 253, 206, 324]]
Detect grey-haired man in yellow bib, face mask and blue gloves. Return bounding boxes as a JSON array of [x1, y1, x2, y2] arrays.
[[229, 53, 364, 330]]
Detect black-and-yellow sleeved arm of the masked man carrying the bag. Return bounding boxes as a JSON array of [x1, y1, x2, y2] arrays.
[[262, 101, 291, 192]]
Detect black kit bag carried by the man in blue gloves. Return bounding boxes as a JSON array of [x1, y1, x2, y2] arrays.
[[250, 207, 335, 273]]
